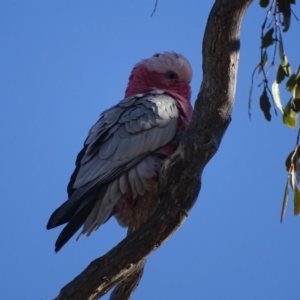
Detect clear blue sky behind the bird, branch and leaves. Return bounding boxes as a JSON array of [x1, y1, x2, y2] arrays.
[[0, 0, 300, 300]]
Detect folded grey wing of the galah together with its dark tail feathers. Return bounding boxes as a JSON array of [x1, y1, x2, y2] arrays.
[[47, 91, 179, 251]]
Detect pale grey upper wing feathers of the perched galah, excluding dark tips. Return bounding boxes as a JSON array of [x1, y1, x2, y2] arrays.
[[73, 93, 179, 189]]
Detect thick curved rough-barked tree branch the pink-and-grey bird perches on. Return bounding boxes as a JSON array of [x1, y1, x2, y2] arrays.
[[56, 0, 252, 300]]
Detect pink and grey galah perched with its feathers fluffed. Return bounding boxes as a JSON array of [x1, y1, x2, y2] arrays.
[[47, 52, 193, 251]]
